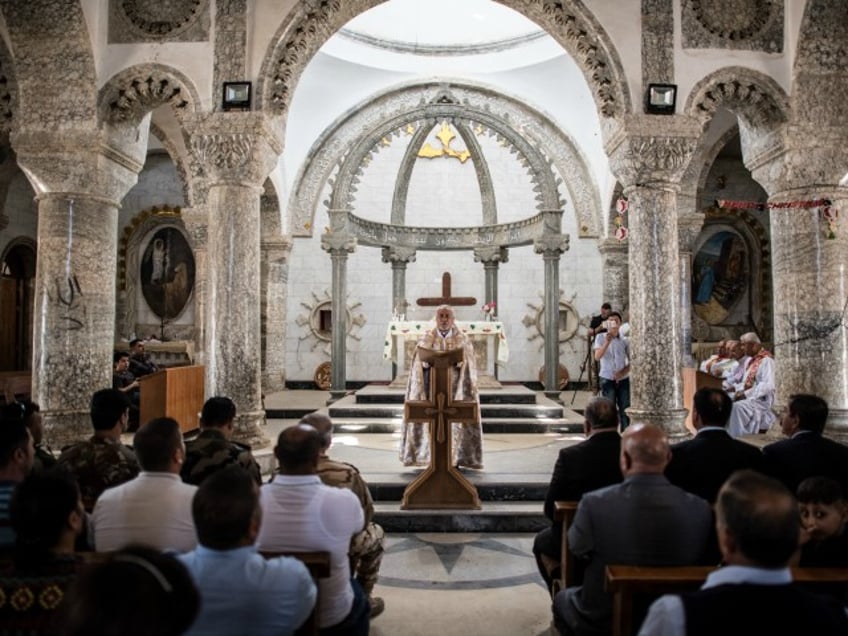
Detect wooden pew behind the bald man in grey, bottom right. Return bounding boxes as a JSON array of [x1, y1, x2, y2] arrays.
[[606, 565, 848, 636]]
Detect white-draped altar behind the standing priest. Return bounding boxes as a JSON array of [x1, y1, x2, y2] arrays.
[[383, 320, 509, 388]]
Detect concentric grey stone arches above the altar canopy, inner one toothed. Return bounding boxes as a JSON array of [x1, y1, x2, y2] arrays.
[[289, 83, 602, 237]]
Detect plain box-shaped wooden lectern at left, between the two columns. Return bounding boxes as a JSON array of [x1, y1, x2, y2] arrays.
[[138, 366, 204, 433]]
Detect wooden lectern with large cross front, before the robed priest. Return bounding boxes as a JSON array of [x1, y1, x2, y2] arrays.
[[400, 347, 481, 510]]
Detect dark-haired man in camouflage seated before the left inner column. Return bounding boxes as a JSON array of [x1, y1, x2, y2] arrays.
[[180, 397, 262, 486]]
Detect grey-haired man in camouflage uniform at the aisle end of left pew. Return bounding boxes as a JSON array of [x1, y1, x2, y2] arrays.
[[300, 412, 386, 618]]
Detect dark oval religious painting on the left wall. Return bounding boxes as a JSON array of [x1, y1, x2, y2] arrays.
[[139, 226, 195, 320]]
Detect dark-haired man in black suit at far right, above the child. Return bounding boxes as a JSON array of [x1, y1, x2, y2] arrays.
[[763, 393, 848, 493]]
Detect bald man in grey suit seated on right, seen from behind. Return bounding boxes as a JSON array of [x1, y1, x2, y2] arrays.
[[553, 424, 712, 636]]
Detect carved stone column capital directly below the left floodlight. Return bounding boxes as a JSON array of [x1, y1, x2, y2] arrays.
[[190, 113, 283, 186]]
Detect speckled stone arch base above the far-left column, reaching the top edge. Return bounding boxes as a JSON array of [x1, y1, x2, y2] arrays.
[[2, 0, 97, 130]]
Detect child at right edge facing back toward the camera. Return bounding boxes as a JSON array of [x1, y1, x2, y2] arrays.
[[796, 477, 848, 567]]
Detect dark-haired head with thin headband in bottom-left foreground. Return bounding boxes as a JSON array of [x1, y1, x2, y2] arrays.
[[59, 545, 200, 636]]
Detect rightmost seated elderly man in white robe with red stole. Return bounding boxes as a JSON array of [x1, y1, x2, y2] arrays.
[[728, 332, 775, 437]]
